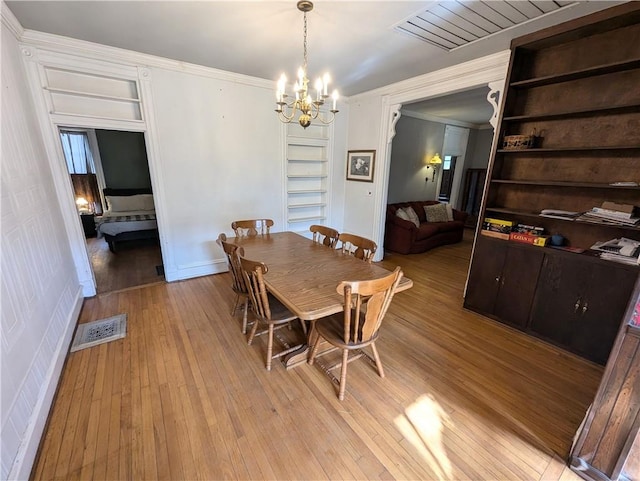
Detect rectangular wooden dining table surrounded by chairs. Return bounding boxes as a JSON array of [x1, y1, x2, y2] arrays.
[[228, 232, 413, 368]]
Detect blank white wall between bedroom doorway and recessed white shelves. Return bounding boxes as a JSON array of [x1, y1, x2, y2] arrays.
[[151, 68, 284, 278]]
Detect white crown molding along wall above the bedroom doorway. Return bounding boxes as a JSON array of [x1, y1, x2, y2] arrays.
[[21, 30, 275, 90]]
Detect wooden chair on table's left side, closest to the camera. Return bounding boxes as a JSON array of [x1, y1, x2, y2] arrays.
[[239, 256, 307, 371]]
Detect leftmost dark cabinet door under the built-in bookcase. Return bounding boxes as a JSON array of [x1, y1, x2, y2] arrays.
[[464, 236, 508, 314]]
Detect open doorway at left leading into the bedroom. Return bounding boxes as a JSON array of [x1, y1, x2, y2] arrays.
[[58, 127, 165, 294]]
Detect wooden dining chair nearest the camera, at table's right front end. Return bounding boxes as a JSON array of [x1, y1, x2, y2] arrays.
[[308, 267, 403, 401]]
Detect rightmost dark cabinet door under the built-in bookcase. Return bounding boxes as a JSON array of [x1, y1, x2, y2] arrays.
[[570, 264, 637, 364]]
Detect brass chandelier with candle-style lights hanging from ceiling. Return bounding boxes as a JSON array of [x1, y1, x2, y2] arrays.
[[276, 0, 338, 129]]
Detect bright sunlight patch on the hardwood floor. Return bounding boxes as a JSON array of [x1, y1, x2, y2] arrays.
[[394, 394, 453, 480]]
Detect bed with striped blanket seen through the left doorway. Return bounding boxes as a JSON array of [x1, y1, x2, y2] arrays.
[[96, 187, 158, 253]]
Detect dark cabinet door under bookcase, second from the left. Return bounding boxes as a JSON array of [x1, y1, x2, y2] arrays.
[[494, 246, 544, 329]]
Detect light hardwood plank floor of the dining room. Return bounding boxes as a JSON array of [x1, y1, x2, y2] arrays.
[[32, 231, 602, 480]]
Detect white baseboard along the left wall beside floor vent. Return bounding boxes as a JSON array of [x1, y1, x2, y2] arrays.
[[8, 287, 84, 480]]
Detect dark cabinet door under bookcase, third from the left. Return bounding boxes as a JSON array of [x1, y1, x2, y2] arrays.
[[530, 255, 592, 347]]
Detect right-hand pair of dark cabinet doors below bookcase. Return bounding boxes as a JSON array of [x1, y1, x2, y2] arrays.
[[529, 254, 637, 364]]
